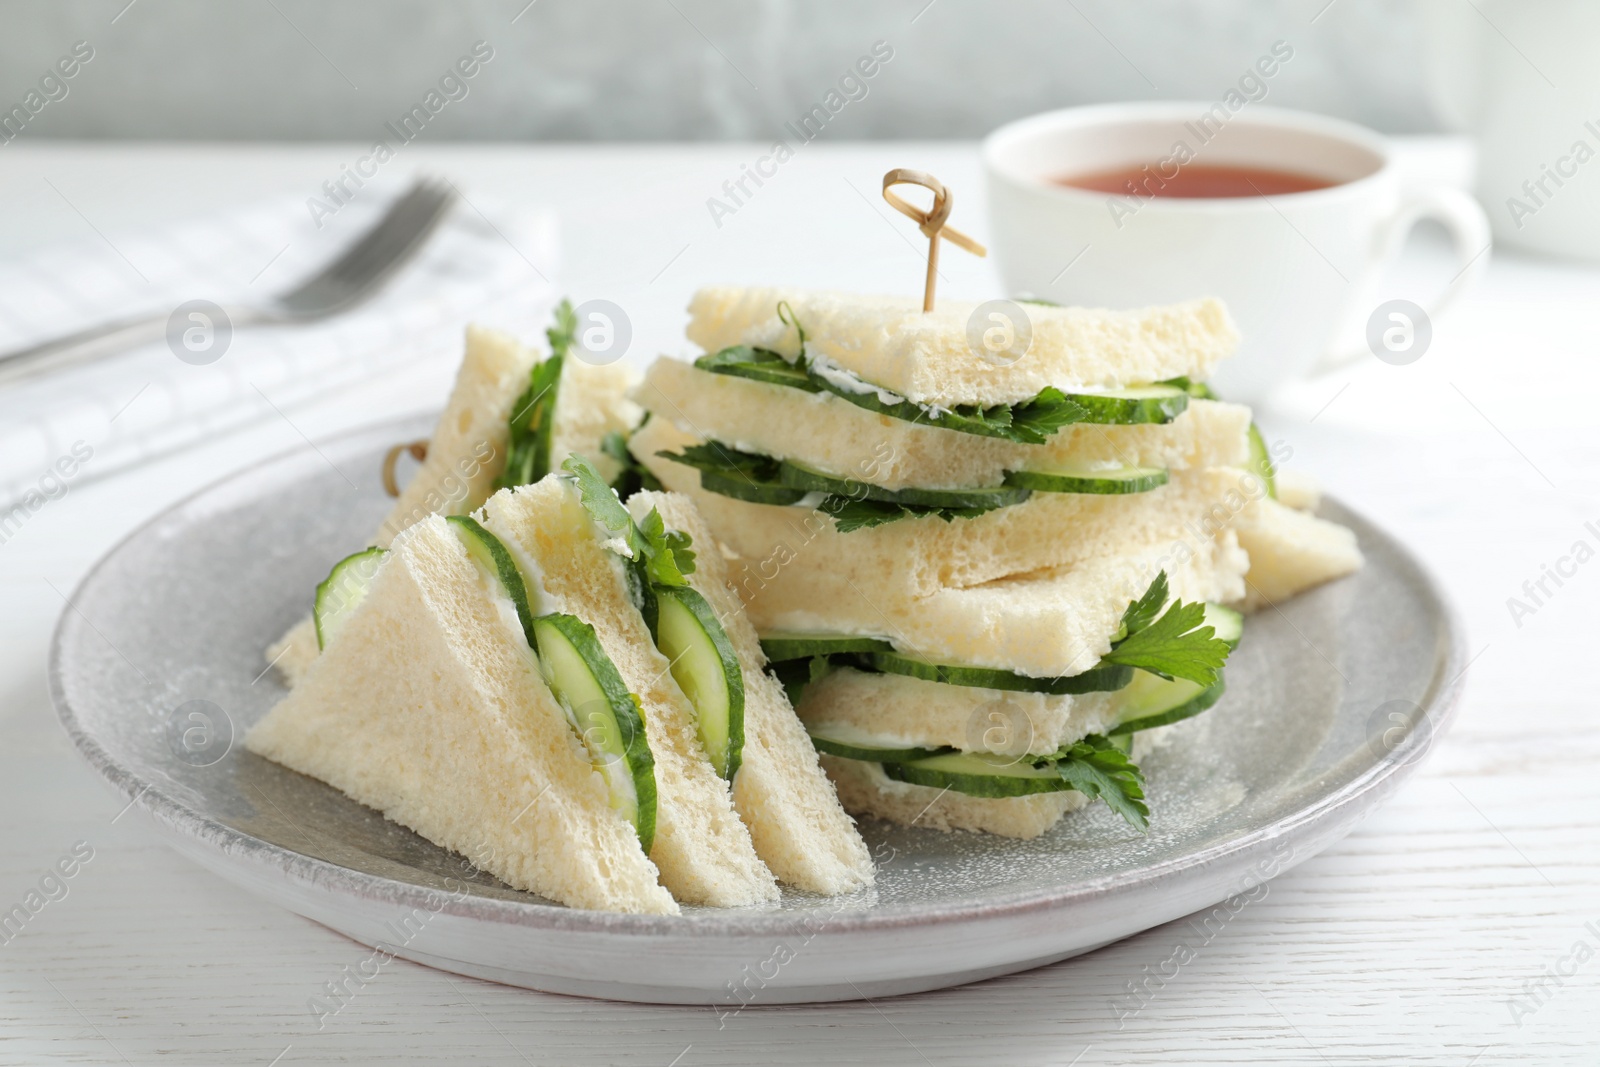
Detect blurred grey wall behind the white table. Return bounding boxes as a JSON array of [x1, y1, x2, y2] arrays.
[[0, 0, 1437, 141]]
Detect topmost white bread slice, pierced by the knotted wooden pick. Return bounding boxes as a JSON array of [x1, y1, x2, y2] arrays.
[[688, 286, 1238, 406]]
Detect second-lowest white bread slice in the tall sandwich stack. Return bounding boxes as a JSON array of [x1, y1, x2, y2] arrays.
[[795, 667, 1118, 757]]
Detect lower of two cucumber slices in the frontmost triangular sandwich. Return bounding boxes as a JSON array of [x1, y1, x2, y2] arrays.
[[533, 614, 656, 854]]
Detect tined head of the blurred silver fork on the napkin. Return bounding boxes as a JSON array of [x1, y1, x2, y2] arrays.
[[277, 178, 456, 317]]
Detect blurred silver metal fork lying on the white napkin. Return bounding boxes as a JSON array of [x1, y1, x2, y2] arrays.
[[0, 178, 458, 381]]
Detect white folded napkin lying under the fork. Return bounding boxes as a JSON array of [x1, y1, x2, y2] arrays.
[[0, 184, 557, 511]]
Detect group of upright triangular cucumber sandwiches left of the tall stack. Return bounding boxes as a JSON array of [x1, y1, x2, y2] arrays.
[[246, 303, 874, 913]]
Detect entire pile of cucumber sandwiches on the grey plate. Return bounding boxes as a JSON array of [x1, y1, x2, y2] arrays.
[[246, 288, 1362, 913]]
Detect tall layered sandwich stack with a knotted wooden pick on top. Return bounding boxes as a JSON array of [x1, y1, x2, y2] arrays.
[[629, 288, 1360, 837]]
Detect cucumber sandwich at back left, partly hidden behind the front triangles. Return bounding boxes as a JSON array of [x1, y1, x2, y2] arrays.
[[267, 301, 640, 685]]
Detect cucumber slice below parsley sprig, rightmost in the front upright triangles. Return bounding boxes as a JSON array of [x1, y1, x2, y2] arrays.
[[654, 584, 744, 782]]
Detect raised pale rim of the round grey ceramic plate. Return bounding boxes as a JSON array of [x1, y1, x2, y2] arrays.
[[46, 411, 1470, 937]]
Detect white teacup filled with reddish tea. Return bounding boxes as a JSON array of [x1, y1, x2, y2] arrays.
[[982, 102, 1490, 402]]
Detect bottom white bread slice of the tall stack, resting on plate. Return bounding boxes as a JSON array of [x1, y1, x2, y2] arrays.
[[822, 729, 1160, 840]]
